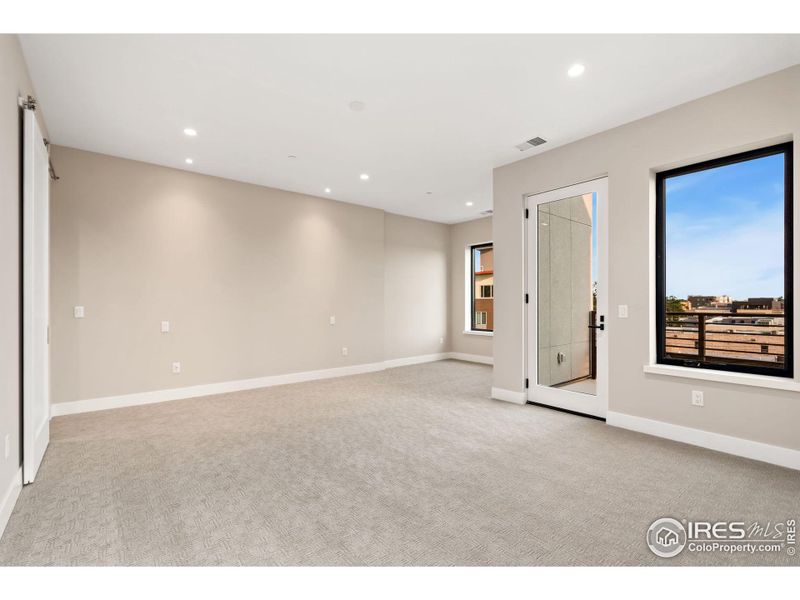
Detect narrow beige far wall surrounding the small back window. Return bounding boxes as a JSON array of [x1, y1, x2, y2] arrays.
[[450, 217, 497, 357]]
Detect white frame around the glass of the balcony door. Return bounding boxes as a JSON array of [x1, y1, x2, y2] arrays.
[[524, 175, 610, 419]]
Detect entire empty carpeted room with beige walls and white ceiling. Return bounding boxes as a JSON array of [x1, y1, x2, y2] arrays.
[[0, 4, 800, 578]]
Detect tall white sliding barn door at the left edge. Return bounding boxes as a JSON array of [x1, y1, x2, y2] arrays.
[[22, 109, 50, 483]]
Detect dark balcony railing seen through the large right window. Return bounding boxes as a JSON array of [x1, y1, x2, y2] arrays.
[[664, 311, 785, 367]]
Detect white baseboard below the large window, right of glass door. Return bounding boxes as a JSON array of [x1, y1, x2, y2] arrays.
[[606, 411, 800, 470]]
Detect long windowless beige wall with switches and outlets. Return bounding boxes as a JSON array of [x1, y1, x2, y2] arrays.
[[51, 147, 449, 403]]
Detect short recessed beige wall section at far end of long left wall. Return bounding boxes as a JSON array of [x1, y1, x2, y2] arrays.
[[384, 213, 450, 359]]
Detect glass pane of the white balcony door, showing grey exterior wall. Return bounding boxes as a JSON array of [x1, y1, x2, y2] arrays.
[[536, 193, 597, 394]]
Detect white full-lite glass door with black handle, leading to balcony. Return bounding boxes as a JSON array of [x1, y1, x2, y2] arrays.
[[526, 178, 609, 418]]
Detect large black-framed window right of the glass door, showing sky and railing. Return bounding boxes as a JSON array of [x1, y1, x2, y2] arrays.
[[656, 143, 793, 377]]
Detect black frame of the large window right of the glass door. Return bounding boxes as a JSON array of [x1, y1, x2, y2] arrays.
[[656, 142, 794, 378]]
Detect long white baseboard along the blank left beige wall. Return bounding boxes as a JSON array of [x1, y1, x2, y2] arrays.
[[50, 352, 468, 417]]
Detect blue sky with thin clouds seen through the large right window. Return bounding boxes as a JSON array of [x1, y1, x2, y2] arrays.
[[666, 154, 784, 299]]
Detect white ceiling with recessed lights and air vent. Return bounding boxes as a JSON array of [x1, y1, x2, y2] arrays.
[[21, 35, 800, 222]]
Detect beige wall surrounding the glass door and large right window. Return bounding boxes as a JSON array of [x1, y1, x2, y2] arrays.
[[493, 66, 800, 449]]
